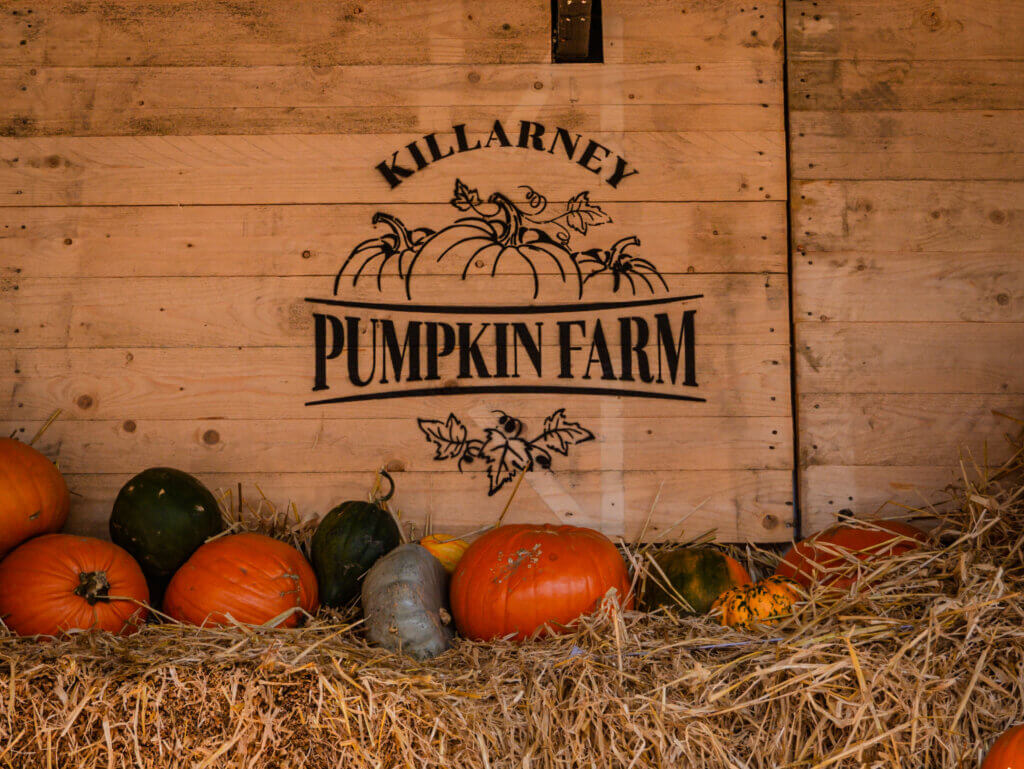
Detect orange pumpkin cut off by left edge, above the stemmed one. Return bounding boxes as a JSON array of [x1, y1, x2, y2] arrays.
[[0, 438, 71, 557]]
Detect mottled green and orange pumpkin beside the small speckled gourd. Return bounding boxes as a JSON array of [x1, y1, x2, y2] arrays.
[[644, 548, 751, 614]]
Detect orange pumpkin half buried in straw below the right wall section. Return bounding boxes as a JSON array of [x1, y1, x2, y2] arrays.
[[775, 520, 926, 590]]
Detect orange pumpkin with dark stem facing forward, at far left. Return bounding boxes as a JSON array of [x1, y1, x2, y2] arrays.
[[0, 535, 150, 636]]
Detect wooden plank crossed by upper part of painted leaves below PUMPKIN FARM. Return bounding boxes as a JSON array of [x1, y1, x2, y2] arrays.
[[0, 415, 793, 475]]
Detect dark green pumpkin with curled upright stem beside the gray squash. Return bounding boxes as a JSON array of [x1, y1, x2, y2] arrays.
[[310, 472, 401, 608]]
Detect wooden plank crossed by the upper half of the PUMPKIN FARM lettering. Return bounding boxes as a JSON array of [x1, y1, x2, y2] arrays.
[[0, 274, 787, 348]]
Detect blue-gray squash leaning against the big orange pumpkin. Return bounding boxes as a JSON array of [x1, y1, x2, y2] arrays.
[[362, 544, 455, 659]]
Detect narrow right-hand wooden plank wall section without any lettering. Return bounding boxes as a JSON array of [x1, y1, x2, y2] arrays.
[[786, 0, 1024, 530]]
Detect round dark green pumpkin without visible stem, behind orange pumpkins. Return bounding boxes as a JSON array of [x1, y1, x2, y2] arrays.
[[111, 467, 224, 605]]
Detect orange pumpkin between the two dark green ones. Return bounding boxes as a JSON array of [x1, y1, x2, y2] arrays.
[[164, 533, 316, 628]]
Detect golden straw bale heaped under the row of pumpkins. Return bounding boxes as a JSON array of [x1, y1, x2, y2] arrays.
[[0, 444, 1024, 769]]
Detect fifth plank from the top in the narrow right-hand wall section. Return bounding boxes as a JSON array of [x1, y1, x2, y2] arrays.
[[794, 249, 1024, 323]]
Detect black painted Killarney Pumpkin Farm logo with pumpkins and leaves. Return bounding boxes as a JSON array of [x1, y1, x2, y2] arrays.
[[306, 135, 705, 495]]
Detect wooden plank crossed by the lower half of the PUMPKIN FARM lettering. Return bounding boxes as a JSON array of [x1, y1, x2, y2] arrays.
[[0, 348, 790, 422]]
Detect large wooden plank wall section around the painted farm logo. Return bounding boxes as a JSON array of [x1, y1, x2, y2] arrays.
[[0, 0, 790, 541]]
